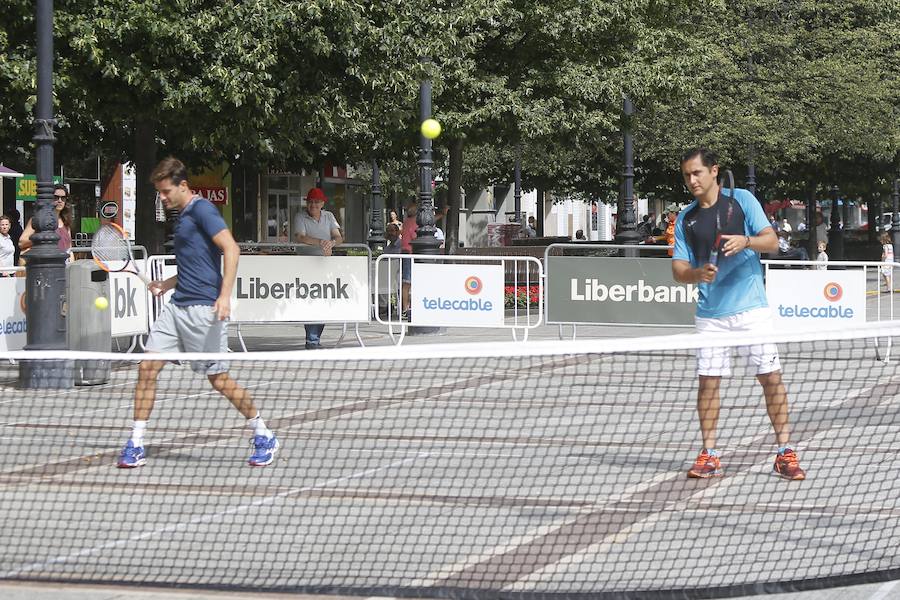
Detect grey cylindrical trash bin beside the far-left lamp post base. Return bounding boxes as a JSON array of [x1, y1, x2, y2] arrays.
[[66, 260, 112, 385]]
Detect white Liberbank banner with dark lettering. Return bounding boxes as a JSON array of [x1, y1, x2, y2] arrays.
[[231, 256, 370, 323]]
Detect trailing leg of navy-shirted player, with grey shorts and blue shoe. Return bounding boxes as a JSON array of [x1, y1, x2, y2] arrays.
[[179, 306, 280, 467]]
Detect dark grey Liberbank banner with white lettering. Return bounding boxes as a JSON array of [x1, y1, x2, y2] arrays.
[[546, 256, 698, 325]]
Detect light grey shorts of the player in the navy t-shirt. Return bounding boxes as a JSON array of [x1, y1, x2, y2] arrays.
[[145, 302, 228, 375]]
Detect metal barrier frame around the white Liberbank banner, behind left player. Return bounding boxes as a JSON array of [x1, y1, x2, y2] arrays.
[[148, 243, 372, 352]]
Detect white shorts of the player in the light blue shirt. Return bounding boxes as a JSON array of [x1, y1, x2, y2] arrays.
[[695, 307, 781, 377]]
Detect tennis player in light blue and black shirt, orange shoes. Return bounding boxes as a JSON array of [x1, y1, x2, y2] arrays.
[[672, 148, 806, 479]]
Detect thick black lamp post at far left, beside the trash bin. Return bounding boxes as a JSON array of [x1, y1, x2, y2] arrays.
[[19, 0, 74, 389]]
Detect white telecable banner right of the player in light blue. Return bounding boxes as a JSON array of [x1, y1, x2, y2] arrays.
[[766, 268, 866, 331]]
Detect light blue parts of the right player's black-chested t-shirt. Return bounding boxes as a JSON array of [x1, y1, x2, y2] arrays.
[[672, 188, 771, 319]]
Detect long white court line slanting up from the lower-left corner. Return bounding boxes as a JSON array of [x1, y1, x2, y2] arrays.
[[0, 453, 428, 579]]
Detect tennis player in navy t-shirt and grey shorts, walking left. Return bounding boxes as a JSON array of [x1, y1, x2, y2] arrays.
[[117, 158, 279, 469]]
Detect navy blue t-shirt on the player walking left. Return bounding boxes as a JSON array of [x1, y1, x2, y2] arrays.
[[172, 196, 226, 306]]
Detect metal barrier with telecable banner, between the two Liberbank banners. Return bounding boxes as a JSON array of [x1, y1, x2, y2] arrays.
[[374, 254, 544, 345]]
